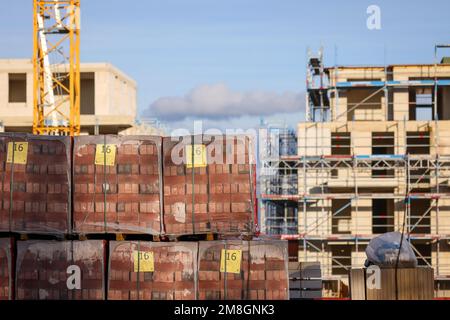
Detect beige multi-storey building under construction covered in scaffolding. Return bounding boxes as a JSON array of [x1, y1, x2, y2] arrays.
[[261, 46, 450, 297]]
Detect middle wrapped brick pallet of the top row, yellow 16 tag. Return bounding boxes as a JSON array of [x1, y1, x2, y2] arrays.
[[73, 135, 162, 235]]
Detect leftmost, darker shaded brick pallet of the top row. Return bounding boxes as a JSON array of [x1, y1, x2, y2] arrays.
[[0, 133, 70, 234]]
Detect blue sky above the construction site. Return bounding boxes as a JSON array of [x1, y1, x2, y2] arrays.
[[0, 0, 450, 131]]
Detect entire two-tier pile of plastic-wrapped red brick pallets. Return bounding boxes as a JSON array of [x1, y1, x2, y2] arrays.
[[0, 134, 289, 300]]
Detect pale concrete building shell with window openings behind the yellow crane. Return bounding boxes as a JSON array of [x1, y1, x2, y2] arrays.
[[0, 59, 137, 134]]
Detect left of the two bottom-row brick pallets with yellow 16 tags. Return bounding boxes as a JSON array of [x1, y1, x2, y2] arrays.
[[108, 241, 197, 300]]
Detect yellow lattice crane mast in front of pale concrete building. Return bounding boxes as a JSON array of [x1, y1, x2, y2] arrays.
[[33, 0, 80, 136]]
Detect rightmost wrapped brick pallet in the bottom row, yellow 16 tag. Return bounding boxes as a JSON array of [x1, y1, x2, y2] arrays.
[[198, 240, 289, 300]]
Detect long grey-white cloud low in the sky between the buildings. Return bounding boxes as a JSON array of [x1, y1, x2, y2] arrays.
[[144, 83, 305, 121]]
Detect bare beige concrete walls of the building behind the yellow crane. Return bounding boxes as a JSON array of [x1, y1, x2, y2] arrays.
[[0, 60, 137, 129]]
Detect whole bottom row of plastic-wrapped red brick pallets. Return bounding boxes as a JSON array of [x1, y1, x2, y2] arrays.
[[0, 239, 289, 300]]
